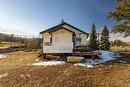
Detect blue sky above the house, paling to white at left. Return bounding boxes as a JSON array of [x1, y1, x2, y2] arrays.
[[0, 0, 116, 34]]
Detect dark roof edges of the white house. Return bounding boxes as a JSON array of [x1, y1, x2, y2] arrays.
[[40, 22, 88, 35]]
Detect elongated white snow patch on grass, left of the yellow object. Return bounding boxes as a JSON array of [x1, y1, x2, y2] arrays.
[[33, 61, 65, 66]]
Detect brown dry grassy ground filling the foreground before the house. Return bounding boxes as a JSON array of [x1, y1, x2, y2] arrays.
[[0, 52, 130, 87]]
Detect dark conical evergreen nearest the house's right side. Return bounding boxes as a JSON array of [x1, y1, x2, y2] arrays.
[[89, 23, 99, 50]]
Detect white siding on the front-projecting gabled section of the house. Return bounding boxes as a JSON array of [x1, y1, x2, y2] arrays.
[[43, 29, 73, 53]]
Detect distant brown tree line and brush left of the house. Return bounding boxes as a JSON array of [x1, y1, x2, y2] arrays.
[[0, 33, 42, 49]]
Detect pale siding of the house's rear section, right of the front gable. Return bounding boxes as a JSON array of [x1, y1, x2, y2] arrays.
[[63, 25, 88, 46]]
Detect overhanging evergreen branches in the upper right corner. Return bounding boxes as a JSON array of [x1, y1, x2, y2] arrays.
[[108, 0, 130, 36]]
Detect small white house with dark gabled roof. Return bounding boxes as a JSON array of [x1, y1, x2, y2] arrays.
[[40, 21, 89, 53]]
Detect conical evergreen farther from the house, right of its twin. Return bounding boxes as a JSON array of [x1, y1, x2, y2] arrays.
[[100, 25, 110, 50]]
